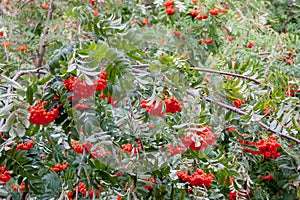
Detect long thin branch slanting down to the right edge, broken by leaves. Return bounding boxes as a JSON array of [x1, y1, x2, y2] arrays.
[[186, 91, 300, 144]]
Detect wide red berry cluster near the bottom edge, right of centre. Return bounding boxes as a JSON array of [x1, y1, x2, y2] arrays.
[[177, 169, 214, 187]]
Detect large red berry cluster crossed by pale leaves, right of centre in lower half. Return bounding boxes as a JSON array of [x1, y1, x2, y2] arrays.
[[182, 126, 218, 151]]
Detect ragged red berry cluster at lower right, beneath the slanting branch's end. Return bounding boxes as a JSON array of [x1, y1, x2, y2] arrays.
[[239, 136, 280, 160]]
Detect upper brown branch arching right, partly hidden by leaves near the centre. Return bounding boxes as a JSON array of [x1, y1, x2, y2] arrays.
[[132, 64, 261, 84]]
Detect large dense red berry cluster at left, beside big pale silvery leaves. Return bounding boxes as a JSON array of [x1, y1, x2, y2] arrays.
[[29, 101, 59, 126]]
